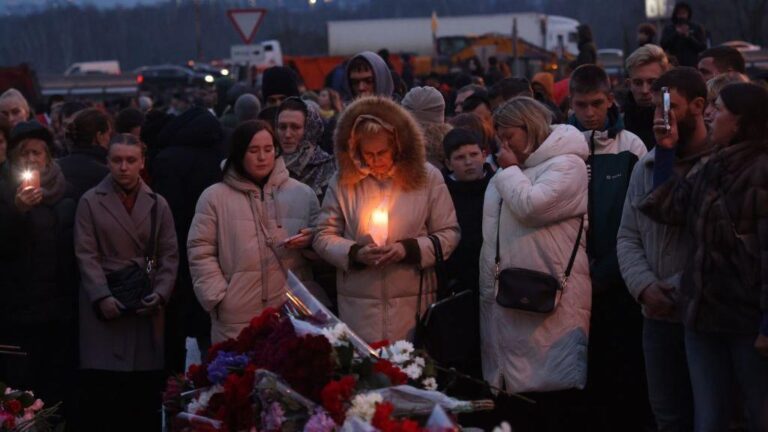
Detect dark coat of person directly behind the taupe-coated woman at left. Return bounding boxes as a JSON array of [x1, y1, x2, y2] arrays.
[[58, 146, 109, 203]]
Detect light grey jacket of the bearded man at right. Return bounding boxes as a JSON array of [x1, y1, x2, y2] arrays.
[[616, 150, 706, 322]]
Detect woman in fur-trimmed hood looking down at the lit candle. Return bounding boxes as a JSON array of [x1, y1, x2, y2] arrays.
[[314, 97, 459, 342]]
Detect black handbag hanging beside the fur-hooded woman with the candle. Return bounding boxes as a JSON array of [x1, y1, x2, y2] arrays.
[[416, 235, 480, 368]]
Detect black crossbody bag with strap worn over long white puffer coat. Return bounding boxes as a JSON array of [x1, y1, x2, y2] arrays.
[[496, 201, 584, 313]]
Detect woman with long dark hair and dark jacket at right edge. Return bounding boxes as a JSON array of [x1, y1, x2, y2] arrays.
[[640, 76, 768, 431]]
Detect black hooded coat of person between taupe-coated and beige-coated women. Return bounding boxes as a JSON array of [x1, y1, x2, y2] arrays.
[[151, 107, 224, 335]]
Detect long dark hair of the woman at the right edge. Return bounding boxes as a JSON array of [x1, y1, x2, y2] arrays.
[[720, 83, 768, 143]]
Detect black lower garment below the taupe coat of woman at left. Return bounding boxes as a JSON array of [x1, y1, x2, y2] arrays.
[[76, 370, 165, 432]]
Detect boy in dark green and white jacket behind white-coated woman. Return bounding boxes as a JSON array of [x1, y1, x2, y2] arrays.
[[569, 65, 650, 431]]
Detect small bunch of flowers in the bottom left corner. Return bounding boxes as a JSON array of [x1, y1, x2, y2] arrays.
[[0, 382, 58, 432]]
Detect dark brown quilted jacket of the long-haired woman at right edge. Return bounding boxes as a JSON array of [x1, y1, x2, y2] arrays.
[[640, 142, 768, 335]]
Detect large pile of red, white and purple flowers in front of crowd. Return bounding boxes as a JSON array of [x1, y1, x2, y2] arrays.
[[164, 272, 496, 432]]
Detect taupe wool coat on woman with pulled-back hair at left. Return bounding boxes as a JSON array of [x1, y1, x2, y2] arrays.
[[75, 175, 179, 371]]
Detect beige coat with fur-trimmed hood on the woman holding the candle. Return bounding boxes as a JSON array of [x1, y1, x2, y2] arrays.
[[314, 97, 459, 342]]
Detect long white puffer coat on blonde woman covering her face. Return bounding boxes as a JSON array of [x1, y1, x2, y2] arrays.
[[480, 125, 592, 393]]
